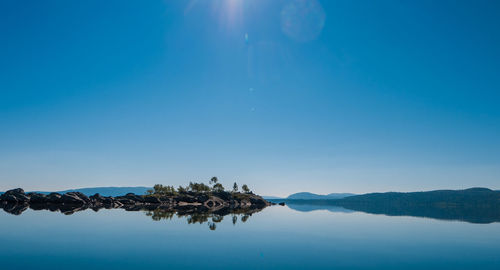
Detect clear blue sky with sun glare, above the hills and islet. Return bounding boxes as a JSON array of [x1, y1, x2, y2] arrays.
[[0, 0, 500, 195]]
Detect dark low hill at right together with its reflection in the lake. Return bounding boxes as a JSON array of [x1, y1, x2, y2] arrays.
[[273, 188, 500, 223]]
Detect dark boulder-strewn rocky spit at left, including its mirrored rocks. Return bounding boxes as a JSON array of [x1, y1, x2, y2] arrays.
[[0, 188, 271, 215]]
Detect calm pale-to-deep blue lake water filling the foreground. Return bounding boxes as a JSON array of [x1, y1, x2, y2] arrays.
[[0, 206, 500, 270]]
